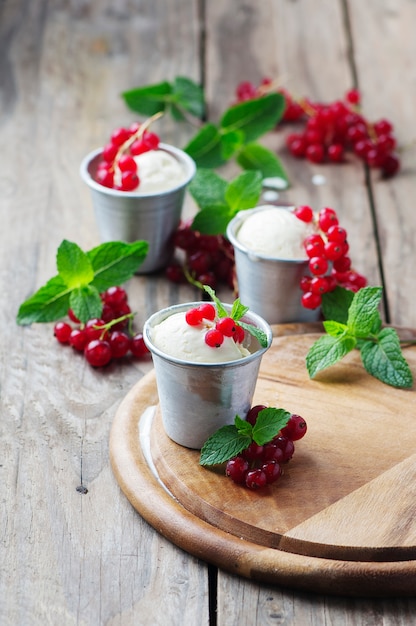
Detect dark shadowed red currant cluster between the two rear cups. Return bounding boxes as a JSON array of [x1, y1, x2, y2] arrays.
[[165, 224, 234, 289]]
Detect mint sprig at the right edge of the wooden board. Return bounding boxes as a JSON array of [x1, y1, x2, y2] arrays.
[[306, 287, 413, 389]]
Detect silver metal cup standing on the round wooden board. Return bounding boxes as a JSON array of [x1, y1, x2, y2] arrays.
[[143, 302, 273, 450]]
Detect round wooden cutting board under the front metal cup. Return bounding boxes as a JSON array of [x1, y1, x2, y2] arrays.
[[110, 325, 416, 596]]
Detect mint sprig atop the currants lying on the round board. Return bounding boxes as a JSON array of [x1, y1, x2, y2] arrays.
[[199, 408, 290, 465]]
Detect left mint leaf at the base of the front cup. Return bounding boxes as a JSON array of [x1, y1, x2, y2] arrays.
[[199, 425, 251, 465]]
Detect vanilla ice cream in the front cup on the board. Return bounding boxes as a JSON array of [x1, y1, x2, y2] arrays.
[[151, 312, 250, 363]]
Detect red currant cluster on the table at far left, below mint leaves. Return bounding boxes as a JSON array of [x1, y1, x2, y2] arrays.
[[54, 286, 149, 367]]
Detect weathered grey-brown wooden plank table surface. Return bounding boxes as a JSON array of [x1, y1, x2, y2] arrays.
[[0, 0, 416, 626]]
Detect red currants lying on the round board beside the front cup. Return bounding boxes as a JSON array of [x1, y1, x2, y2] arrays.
[[225, 404, 307, 489]]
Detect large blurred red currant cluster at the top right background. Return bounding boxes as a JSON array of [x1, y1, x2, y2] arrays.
[[236, 78, 400, 178]]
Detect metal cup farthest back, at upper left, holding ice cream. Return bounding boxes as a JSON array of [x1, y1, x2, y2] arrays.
[[80, 143, 196, 274]]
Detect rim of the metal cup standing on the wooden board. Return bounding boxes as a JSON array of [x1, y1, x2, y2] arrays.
[[143, 301, 273, 368]]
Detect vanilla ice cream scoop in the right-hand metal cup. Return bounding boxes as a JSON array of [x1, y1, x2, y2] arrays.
[[236, 205, 313, 259]]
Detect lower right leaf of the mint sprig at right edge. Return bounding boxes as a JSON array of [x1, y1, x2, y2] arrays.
[[360, 328, 413, 389]]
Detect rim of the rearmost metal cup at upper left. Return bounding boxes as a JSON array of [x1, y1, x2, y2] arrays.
[[79, 143, 196, 198]]
